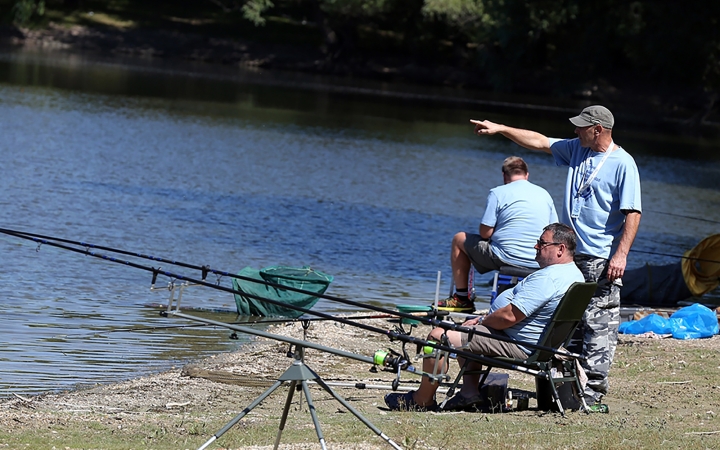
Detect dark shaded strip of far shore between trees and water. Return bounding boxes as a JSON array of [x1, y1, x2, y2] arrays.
[[0, 23, 720, 137]]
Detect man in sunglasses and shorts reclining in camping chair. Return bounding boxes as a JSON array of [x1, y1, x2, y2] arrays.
[[385, 223, 585, 411]]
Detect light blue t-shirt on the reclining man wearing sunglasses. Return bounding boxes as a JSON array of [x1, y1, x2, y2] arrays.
[[490, 262, 585, 354]]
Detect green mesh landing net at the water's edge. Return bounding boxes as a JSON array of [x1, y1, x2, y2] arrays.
[[233, 266, 333, 318]]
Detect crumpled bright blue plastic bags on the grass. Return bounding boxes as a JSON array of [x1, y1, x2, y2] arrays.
[[618, 303, 718, 339]]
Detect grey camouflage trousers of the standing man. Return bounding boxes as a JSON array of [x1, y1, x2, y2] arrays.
[[569, 255, 622, 403]]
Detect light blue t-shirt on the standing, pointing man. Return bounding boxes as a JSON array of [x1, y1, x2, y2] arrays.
[[550, 138, 642, 259]]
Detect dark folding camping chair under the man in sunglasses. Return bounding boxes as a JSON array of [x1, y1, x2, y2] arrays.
[[446, 283, 597, 415]]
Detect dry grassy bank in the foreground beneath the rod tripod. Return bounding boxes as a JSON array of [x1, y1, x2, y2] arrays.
[[0, 321, 720, 449]]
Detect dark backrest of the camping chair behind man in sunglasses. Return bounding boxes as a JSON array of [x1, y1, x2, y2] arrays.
[[528, 283, 597, 361]]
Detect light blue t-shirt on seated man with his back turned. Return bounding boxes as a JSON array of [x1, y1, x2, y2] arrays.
[[480, 180, 558, 268]]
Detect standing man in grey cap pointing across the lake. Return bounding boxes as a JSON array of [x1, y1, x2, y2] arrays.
[[471, 105, 642, 405]]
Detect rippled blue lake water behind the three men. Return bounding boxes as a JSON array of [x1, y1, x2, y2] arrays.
[[0, 47, 720, 396]]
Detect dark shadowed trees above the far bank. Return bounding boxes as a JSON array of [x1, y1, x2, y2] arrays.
[[0, 0, 720, 123]]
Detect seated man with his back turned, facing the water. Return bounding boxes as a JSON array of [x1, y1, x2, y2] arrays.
[[438, 156, 557, 312]]
